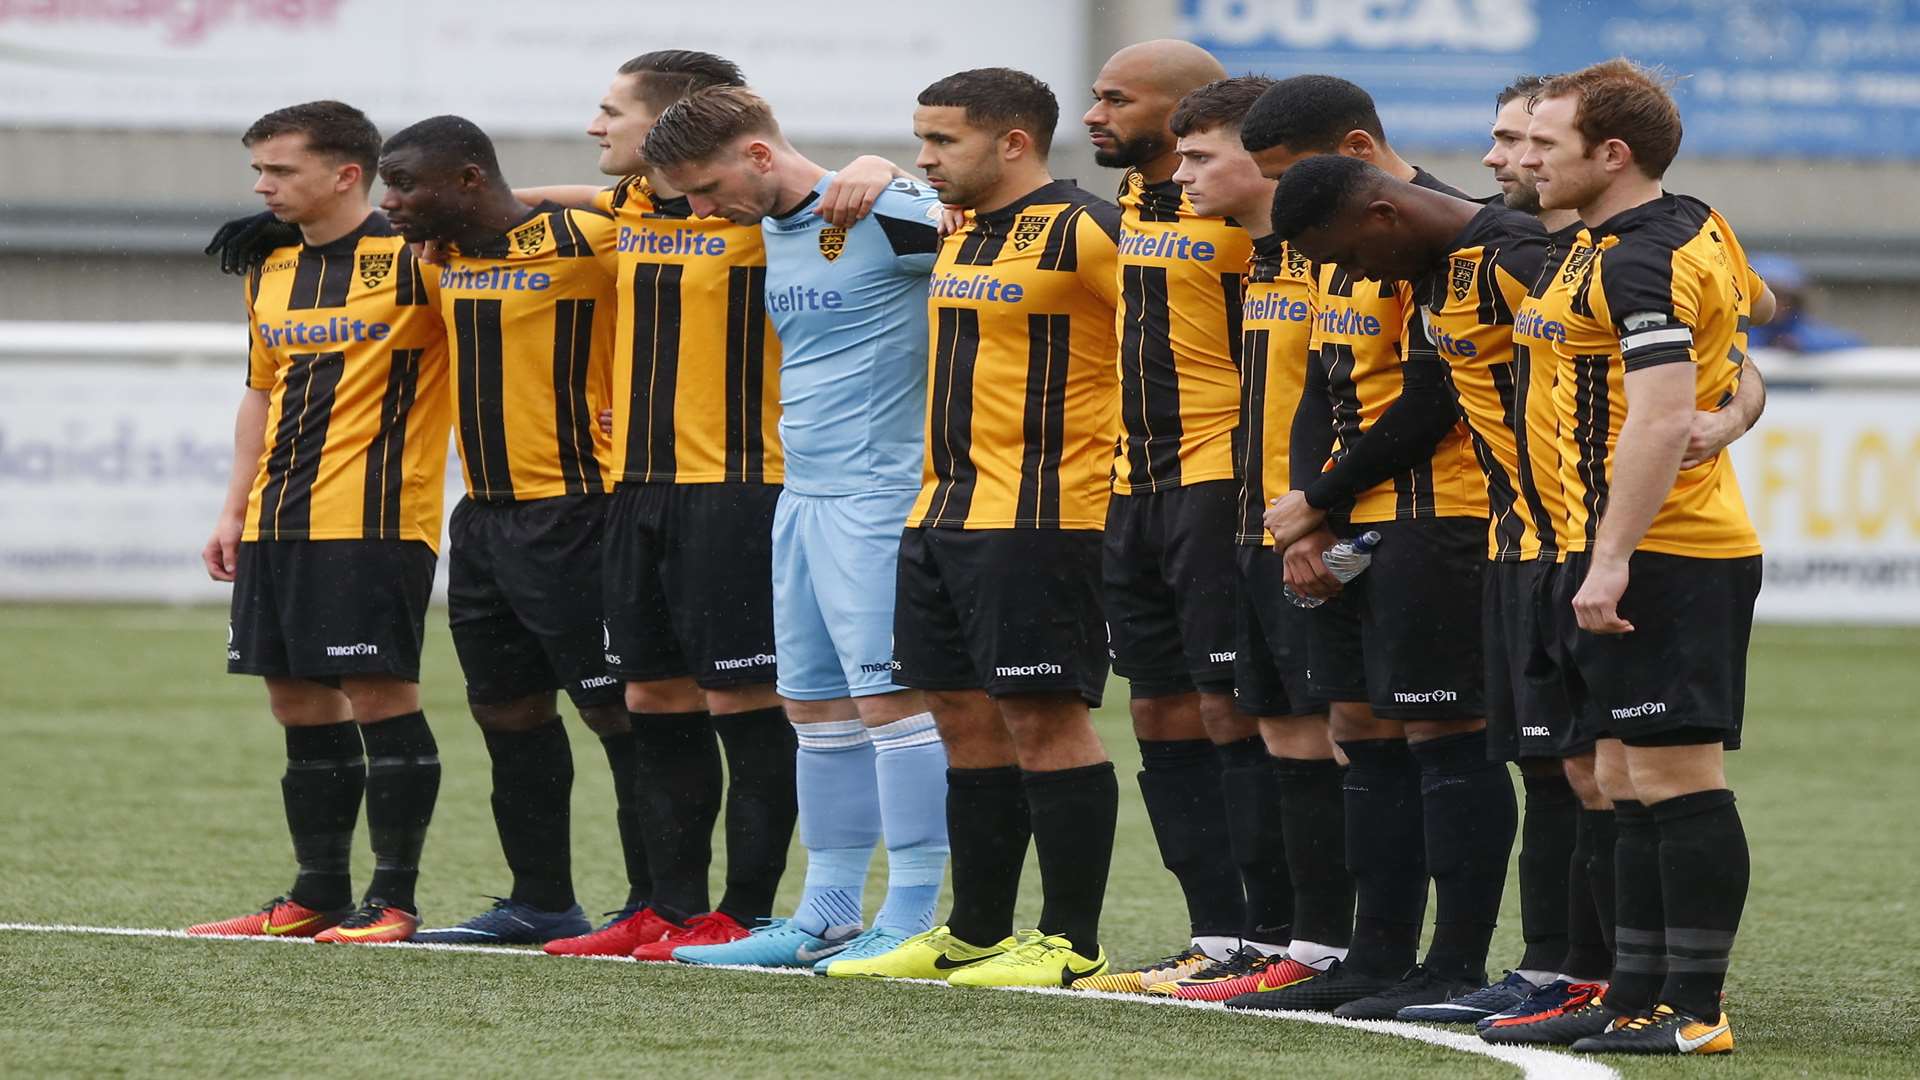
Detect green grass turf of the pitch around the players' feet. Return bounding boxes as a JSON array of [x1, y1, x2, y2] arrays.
[[0, 607, 1920, 1076]]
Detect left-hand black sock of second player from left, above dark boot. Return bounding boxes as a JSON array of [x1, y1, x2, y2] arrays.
[[482, 717, 574, 911]]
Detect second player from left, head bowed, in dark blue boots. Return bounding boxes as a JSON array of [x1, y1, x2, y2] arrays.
[[380, 115, 628, 944]]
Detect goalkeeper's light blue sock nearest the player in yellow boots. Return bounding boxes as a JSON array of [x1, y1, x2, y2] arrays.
[[868, 713, 947, 936]]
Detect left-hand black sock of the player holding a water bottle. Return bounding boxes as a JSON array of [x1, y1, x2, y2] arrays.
[[1336, 738, 1427, 978]]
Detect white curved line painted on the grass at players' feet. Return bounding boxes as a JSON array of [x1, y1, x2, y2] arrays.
[[0, 922, 1619, 1080]]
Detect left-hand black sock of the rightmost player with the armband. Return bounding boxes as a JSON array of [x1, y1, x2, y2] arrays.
[[1607, 799, 1667, 1017]]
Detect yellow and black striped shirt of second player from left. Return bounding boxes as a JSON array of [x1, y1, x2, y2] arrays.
[[440, 202, 618, 500]]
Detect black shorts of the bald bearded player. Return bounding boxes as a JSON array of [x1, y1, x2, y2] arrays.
[[1100, 480, 1240, 698]]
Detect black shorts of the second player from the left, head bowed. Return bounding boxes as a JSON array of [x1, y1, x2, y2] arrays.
[[447, 496, 626, 705]]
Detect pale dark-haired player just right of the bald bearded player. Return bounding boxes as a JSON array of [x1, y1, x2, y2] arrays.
[[1152, 75, 1354, 1001]]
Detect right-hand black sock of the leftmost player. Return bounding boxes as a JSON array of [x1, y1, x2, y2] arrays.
[[361, 713, 440, 913]]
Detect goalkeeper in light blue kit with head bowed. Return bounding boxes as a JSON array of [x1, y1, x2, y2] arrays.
[[643, 86, 947, 970]]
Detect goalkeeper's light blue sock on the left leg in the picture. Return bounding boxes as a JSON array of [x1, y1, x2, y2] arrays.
[[793, 721, 881, 936]]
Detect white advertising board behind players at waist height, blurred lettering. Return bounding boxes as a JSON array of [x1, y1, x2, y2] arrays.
[[0, 336, 1920, 625]]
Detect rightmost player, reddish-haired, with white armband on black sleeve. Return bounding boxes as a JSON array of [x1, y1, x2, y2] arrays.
[[1488, 60, 1764, 1055]]
